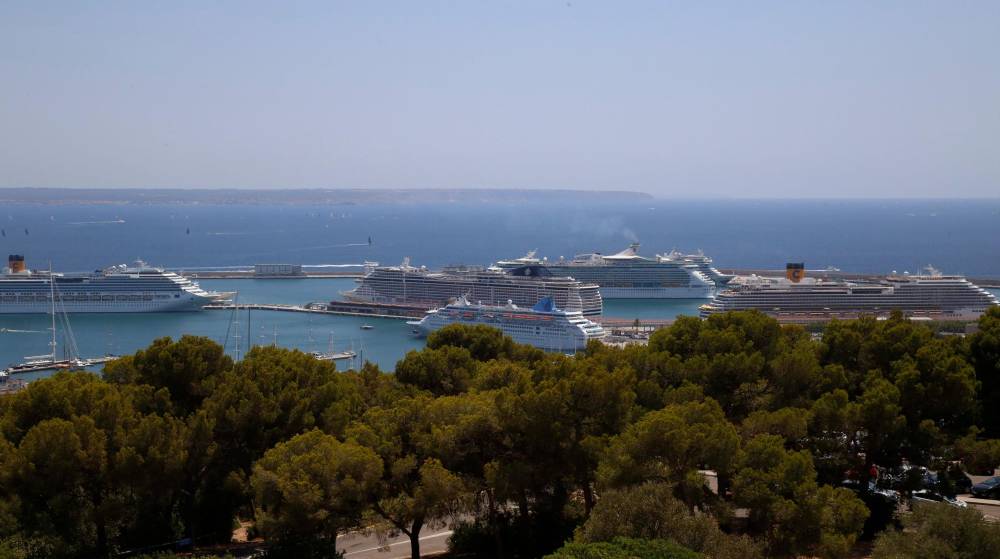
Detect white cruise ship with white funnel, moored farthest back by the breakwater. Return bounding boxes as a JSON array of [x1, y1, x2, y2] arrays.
[[497, 243, 723, 299]]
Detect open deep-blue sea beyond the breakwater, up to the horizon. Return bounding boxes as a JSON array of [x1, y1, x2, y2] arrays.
[[0, 199, 1000, 277]]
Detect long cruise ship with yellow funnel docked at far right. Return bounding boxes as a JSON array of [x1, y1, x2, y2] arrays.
[[701, 263, 998, 322]]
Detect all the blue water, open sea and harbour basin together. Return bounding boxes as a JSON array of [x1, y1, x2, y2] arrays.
[[0, 199, 1000, 380]]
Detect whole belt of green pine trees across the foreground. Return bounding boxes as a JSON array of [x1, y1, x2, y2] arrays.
[[0, 316, 1000, 559]]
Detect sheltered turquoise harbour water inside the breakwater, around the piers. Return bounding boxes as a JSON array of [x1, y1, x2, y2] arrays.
[[0, 277, 997, 380]]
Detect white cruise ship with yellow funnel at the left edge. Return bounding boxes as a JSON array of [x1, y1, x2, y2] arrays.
[[0, 254, 230, 314]]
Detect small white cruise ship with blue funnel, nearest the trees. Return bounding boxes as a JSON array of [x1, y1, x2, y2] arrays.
[[407, 297, 605, 352]]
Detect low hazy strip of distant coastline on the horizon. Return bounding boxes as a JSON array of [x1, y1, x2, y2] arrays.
[[0, 188, 653, 205]]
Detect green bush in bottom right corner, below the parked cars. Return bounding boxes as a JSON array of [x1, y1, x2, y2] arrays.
[[872, 504, 1000, 559]]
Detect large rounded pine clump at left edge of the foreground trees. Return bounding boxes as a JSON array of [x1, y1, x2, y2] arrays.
[[0, 373, 199, 557]]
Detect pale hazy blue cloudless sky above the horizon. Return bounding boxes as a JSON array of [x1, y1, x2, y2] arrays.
[[0, 0, 1000, 198]]
